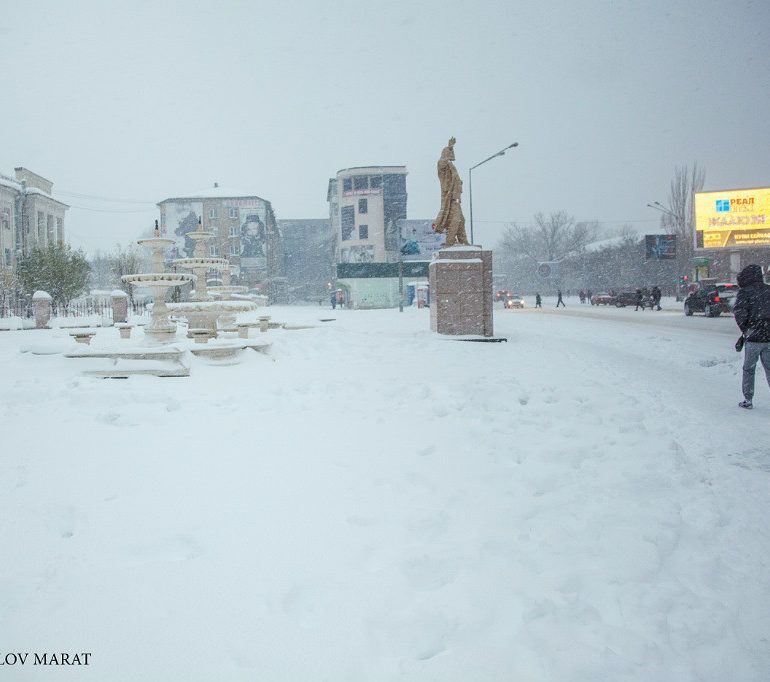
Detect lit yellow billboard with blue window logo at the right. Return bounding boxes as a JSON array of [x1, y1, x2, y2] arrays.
[[693, 187, 770, 249]]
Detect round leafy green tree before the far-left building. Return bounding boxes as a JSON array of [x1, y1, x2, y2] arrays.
[[18, 243, 91, 305]]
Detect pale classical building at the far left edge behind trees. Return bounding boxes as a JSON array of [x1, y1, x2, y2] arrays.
[[0, 167, 69, 271]]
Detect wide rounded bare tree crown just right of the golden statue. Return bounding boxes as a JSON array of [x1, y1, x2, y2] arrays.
[[500, 211, 597, 261]]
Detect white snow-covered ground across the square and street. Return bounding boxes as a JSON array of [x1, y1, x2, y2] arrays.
[[0, 299, 770, 682]]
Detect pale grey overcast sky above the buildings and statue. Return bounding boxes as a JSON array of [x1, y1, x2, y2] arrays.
[[0, 0, 770, 251]]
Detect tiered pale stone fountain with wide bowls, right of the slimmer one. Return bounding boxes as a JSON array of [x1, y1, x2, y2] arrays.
[[169, 219, 257, 337]]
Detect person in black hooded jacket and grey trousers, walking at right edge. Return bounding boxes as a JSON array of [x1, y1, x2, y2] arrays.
[[733, 265, 770, 410]]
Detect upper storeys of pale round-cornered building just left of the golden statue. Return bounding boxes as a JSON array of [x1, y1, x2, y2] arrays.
[[326, 166, 407, 263]]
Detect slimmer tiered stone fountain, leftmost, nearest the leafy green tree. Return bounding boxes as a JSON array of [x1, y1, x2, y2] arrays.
[[121, 220, 196, 343]]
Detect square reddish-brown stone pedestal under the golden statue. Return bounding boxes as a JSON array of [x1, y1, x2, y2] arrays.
[[429, 245, 494, 336]]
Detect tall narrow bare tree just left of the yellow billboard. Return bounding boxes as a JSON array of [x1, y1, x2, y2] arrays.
[[660, 163, 706, 274]]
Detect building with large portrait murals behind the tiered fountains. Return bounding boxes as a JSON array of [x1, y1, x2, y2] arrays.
[[158, 183, 287, 303]]
